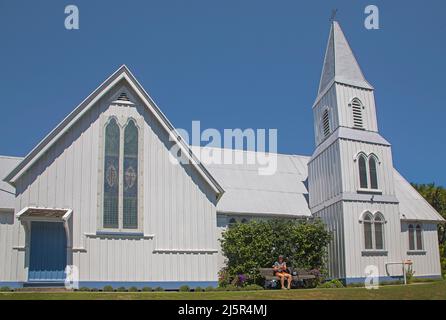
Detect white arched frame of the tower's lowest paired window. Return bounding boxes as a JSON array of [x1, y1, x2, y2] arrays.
[[359, 211, 387, 251]]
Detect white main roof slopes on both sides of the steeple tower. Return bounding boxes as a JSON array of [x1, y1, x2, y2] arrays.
[[201, 147, 444, 222]]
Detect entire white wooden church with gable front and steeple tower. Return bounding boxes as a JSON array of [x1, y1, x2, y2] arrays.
[[0, 22, 444, 289]]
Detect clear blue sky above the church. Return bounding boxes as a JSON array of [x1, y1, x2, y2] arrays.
[[0, 0, 446, 185]]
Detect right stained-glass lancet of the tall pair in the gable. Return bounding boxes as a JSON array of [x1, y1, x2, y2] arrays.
[[123, 120, 138, 229]]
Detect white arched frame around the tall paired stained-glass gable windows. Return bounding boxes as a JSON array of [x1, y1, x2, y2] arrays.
[[97, 112, 144, 234]]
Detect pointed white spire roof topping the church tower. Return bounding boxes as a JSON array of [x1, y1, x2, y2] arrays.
[[318, 21, 373, 95]]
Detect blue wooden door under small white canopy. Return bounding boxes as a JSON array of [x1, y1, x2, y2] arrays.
[[28, 221, 67, 281]]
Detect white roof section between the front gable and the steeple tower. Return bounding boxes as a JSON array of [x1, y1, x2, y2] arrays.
[[197, 147, 311, 217]]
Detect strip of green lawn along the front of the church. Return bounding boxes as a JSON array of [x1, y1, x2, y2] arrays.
[[0, 281, 446, 300]]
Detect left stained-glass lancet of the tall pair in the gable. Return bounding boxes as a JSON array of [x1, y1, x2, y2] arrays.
[[103, 119, 120, 228]]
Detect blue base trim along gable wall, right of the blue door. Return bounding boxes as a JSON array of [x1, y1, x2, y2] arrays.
[[79, 281, 218, 290]]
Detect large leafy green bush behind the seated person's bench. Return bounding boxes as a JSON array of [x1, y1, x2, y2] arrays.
[[220, 219, 331, 282]]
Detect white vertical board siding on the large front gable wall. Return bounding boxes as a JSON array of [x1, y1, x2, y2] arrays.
[[9, 88, 217, 281]]
